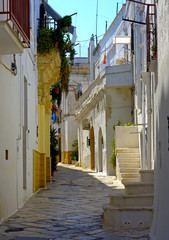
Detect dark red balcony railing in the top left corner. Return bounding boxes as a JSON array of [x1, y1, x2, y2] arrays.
[[0, 0, 30, 47]]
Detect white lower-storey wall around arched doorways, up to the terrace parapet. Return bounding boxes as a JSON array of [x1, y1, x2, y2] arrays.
[[76, 65, 132, 175]]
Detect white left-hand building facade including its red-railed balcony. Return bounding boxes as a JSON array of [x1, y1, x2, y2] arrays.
[[0, 0, 38, 222]]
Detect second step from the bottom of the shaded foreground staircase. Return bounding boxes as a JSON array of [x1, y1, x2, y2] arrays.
[[110, 194, 154, 208]]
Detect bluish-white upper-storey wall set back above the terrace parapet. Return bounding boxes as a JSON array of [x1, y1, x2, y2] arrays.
[[93, 5, 131, 79]]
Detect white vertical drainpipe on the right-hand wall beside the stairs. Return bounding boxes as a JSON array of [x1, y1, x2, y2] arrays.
[[142, 72, 152, 170]]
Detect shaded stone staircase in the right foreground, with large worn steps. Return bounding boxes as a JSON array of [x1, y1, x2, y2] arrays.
[[103, 170, 154, 231]]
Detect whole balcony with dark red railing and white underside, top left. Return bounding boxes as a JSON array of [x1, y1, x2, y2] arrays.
[[0, 0, 30, 55]]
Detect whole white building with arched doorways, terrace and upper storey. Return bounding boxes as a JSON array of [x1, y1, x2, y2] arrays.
[[76, 5, 133, 175]]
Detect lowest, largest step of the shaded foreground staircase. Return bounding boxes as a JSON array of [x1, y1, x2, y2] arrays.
[[103, 204, 153, 231]]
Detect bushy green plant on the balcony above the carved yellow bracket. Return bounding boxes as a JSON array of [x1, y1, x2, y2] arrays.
[[37, 27, 55, 55]]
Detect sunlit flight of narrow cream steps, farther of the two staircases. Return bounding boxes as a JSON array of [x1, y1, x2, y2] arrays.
[[116, 148, 141, 183]]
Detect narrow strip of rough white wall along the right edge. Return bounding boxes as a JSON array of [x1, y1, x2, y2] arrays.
[[151, 0, 169, 240]]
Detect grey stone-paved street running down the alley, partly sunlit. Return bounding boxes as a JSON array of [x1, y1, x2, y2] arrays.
[[0, 164, 149, 240]]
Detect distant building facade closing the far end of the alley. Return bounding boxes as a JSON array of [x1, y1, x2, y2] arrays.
[[61, 58, 90, 163]]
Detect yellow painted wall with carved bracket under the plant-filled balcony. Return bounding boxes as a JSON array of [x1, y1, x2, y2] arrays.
[[36, 50, 61, 192]]
